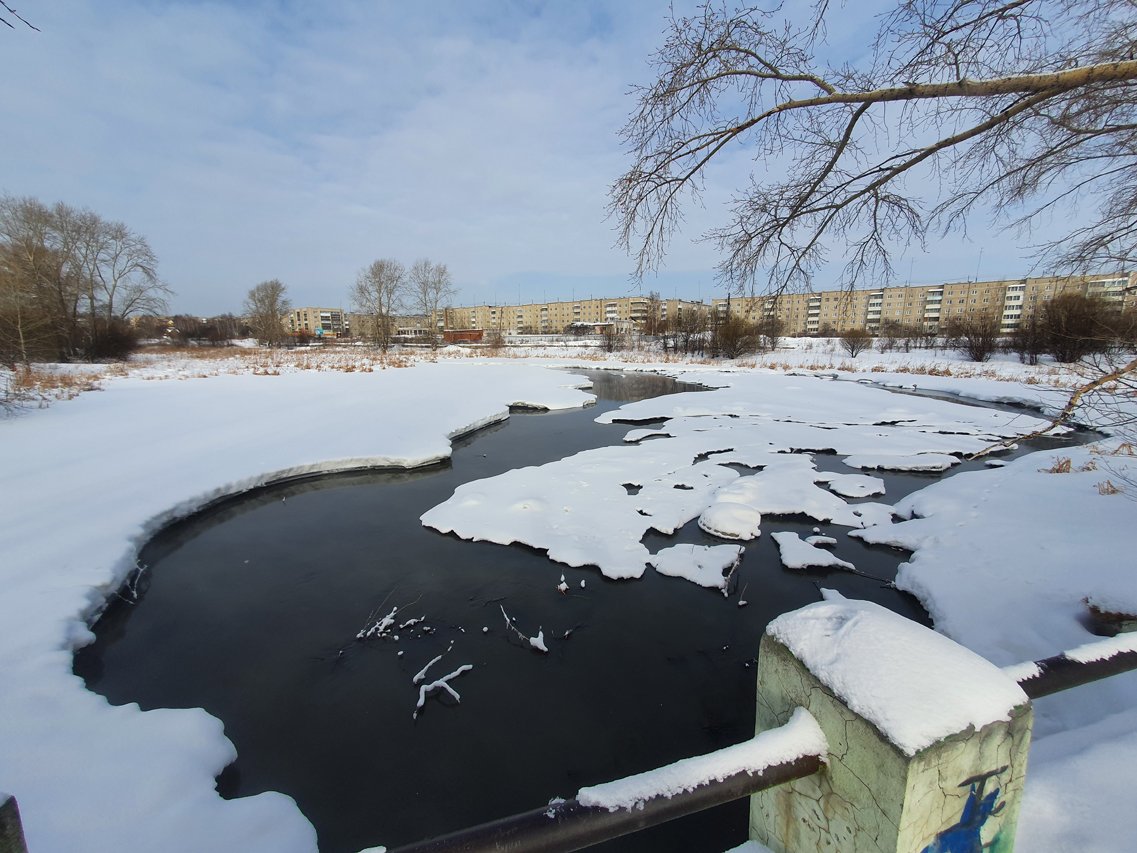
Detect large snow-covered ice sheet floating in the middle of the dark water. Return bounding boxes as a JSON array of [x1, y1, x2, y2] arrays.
[[422, 374, 1043, 579]]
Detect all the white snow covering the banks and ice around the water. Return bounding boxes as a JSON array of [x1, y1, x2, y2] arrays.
[[0, 341, 1137, 853]]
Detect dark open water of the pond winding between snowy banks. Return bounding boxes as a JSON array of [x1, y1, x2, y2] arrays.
[[75, 372, 1073, 853]]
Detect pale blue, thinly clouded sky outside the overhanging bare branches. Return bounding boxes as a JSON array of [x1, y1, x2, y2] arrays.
[[0, 0, 1082, 315]]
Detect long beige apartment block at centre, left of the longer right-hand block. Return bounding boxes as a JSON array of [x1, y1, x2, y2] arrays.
[[442, 296, 706, 334]]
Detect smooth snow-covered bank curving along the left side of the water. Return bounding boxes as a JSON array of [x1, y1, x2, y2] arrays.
[[0, 362, 591, 853]]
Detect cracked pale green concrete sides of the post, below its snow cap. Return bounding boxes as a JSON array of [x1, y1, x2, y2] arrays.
[[750, 636, 1031, 853]]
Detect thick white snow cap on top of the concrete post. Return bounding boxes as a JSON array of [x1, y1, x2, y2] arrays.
[[766, 595, 1028, 755]]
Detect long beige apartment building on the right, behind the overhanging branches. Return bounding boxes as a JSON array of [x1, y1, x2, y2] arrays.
[[713, 273, 1137, 336]]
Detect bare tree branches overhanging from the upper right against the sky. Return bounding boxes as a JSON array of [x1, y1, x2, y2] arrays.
[[611, 0, 1137, 441]]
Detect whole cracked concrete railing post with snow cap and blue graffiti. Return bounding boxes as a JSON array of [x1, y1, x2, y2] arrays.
[[750, 593, 1031, 853]]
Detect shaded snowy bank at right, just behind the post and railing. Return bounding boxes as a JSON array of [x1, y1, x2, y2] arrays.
[[849, 445, 1137, 700]]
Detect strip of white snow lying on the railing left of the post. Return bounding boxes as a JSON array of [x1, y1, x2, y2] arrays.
[[576, 707, 829, 812]]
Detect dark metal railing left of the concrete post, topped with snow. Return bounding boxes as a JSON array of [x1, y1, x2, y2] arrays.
[[391, 709, 829, 853]]
